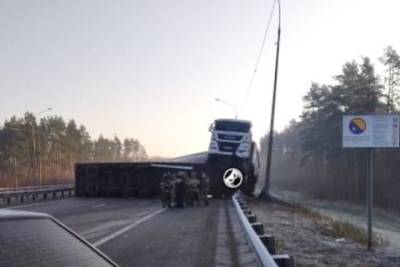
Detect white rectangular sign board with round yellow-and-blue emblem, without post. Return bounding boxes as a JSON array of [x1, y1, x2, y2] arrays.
[[342, 115, 400, 148]]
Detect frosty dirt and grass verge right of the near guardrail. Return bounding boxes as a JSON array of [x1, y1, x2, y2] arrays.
[[247, 199, 400, 266]]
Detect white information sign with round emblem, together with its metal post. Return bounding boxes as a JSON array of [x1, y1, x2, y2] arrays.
[[342, 115, 400, 250]]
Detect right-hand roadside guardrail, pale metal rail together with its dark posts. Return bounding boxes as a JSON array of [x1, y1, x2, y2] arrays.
[[232, 193, 294, 267]]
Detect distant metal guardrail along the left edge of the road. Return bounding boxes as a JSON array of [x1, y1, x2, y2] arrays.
[[0, 184, 75, 206]]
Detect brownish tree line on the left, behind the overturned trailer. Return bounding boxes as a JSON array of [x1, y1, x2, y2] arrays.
[[0, 112, 147, 187]]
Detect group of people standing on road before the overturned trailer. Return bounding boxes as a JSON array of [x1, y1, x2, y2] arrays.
[[160, 171, 210, 208]]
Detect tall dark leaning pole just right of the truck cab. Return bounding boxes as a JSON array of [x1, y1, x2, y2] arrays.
[[264, 0, 281, 196]]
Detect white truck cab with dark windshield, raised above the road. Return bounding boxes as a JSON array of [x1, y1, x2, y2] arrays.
[[208, 119, 252, 159]]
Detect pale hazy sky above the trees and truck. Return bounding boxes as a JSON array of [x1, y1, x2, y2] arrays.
[[0, 0, 400, 156]]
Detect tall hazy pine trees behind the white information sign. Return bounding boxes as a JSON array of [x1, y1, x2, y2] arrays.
[[261, 46, 400, 214]]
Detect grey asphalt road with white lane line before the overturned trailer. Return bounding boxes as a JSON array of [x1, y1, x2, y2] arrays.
[[10, 198, 257, 267]]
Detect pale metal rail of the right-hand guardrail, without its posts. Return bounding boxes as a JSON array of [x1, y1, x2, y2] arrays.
[[232, 195, 278, 267]]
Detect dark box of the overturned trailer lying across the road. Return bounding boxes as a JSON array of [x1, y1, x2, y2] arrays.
[[75, 162, 205, 197]]
